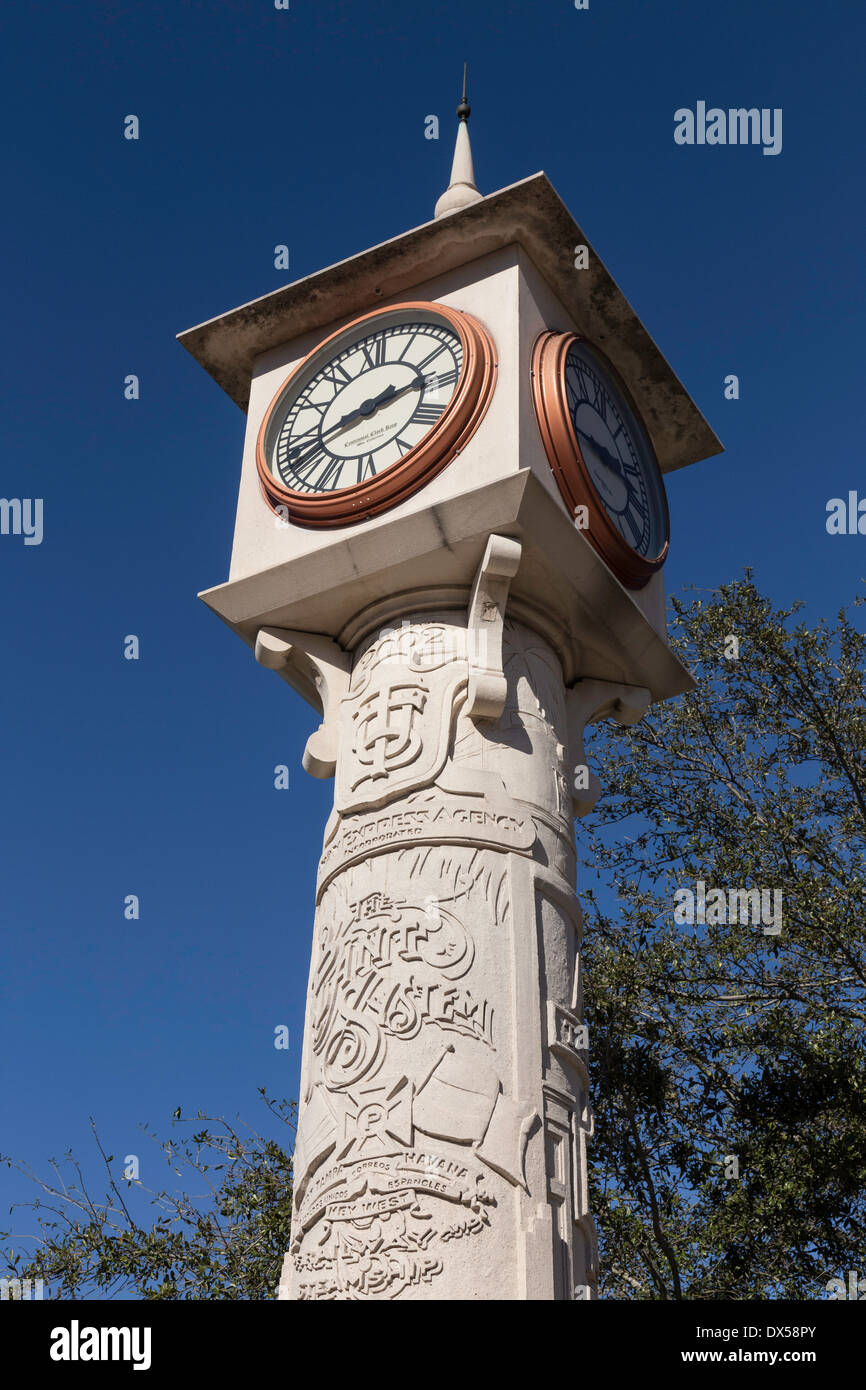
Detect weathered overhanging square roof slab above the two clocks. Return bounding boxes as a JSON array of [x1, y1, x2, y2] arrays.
[[178, 172, 723, 473]]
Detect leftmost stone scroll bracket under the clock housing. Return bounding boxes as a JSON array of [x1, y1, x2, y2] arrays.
[[256, 627, 352, 777]]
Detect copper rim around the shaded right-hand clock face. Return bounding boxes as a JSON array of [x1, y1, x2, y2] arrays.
[[531, 329, 670, 589]]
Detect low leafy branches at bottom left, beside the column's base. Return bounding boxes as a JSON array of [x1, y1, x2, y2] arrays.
[[0, 1090, 295, 1300]]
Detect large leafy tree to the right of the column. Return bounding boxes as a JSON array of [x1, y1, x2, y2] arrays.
[[578, 571, 866, 1298]]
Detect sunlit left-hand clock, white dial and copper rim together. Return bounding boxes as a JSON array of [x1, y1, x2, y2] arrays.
[[257, 304, 495, 525]]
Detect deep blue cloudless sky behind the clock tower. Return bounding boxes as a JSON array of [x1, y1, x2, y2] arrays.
[[0, 0, 866, 1262]]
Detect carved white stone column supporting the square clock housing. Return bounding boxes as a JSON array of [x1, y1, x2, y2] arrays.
[[273, 538, 639, 1300]]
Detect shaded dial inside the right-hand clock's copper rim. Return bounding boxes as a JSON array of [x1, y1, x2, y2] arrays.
[[566, 342, 667, 559]]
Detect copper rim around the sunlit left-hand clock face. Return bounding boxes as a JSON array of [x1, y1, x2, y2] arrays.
[[256, 300, 496, 527]]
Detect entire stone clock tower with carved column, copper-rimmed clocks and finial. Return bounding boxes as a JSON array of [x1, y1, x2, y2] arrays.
[[179, 92, 720, 1300]]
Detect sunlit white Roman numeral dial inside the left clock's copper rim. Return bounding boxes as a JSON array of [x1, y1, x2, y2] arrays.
[[265, 309, 463, 493]]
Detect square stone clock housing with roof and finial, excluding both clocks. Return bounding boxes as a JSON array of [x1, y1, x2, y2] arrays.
[[179, 152, 721, 699]]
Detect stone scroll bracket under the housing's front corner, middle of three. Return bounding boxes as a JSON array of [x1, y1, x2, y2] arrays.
[[466, 535, 523, 720]]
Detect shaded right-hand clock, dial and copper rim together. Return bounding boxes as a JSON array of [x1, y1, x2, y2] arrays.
[[532, 332, 669, 588]]
